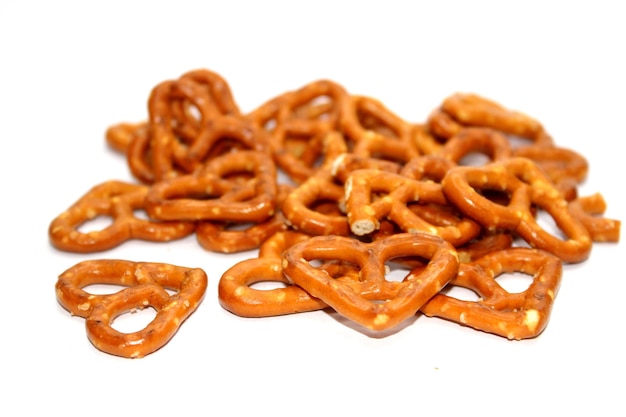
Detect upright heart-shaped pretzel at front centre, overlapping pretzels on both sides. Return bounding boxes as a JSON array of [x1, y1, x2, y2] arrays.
[[283, 233, 459, 331]]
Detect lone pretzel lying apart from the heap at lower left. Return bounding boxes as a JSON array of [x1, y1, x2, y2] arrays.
[[55, 259, 207, 358]]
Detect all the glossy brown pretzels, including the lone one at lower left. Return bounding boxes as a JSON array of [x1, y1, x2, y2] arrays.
[[49, 69, 621, 358]]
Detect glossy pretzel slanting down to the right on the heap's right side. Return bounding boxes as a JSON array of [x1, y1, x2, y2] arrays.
[[442, 157, 592, 263]]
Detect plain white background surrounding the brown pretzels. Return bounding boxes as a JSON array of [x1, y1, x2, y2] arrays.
[[0, 0, 626, 416]]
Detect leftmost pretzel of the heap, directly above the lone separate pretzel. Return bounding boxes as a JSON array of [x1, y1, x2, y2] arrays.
[[48, 180, 195, 253]]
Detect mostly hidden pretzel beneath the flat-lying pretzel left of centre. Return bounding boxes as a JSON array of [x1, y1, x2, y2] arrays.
[[196, 184, 293, 253]]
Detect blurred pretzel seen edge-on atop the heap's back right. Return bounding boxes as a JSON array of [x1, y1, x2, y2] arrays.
[[428, 93, 553, 146]]
